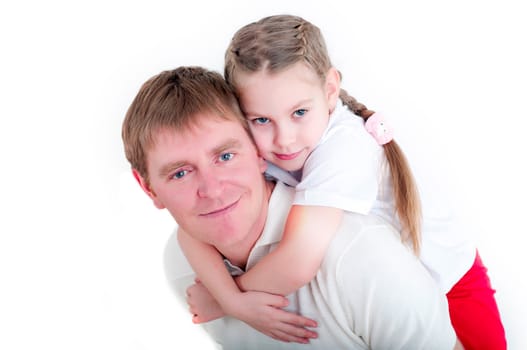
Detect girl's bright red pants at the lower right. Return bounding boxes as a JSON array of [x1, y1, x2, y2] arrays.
[[447, 253, 507, 350]]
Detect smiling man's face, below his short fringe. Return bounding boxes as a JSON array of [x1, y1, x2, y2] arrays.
[[140, 115, 268, 250]]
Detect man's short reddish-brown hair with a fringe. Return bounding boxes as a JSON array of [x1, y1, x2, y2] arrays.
[[122, 67, 250, 181]]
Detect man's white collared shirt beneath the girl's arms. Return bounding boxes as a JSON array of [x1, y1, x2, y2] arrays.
[[166, 183, 456, 350]]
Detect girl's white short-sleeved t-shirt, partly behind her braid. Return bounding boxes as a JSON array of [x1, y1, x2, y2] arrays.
[[267, 100, 476, 293]]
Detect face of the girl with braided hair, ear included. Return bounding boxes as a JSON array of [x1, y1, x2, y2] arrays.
[[236, 62, 339, 171]]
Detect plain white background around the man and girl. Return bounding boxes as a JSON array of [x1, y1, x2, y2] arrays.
[[0, 0, 527, 350]]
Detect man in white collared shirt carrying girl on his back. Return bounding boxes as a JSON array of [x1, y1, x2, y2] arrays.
[[123, 67, 462, 349]]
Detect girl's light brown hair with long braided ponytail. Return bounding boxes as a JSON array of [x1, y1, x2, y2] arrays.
[[224, 15, 421, 254]]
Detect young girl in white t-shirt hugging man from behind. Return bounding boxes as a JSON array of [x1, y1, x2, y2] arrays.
[[179, 15, 506, 349]]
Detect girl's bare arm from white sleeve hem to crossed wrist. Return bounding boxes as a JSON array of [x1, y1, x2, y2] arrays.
[[236, 205, 343, 295]]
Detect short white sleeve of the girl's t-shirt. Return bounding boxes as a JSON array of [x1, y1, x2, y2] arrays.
[[295, 116, 384, 214]]
